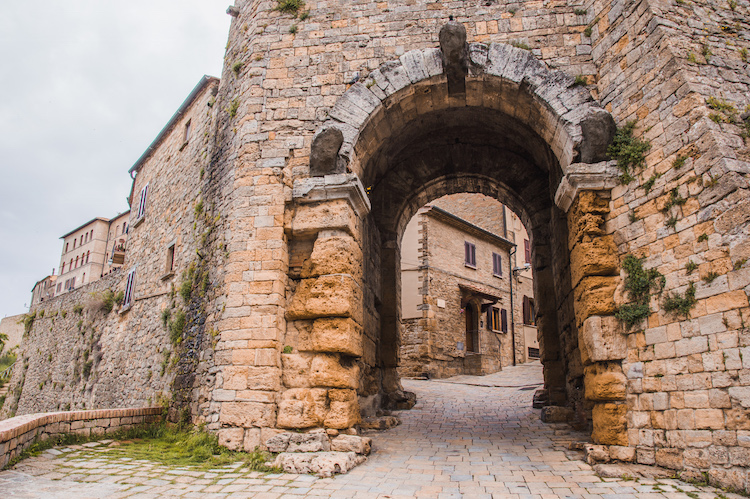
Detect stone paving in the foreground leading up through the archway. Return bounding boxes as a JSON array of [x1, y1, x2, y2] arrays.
[[0, 363, 740, 499]]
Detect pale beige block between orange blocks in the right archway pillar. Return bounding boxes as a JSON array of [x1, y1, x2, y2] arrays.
[[578, 315, 628, 364]]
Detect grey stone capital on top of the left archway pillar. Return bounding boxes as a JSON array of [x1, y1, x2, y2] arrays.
[[292, 173, 371, 218]]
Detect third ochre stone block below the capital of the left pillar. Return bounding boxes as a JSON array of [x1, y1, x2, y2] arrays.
[[287, 274, 362, 322]]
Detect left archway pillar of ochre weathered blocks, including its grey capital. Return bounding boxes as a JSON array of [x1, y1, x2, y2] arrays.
[[277, 174, 370, 429]]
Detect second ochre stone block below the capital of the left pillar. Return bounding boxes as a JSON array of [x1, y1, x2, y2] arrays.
[[301, 236, 362, 278]]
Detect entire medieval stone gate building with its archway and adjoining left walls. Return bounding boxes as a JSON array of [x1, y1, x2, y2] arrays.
[[3, 0, 750, 490]]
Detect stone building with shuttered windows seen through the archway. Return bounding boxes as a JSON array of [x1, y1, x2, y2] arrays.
[[399, 194, 539, 377]]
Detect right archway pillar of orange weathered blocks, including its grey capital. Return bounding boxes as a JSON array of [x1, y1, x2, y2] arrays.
[[555, 162, 628, 446]]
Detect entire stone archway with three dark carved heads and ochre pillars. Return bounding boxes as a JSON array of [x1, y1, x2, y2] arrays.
[[288, 23, 628, 445]]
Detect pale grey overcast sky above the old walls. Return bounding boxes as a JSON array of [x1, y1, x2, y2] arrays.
[[0, 0, 232, 318]]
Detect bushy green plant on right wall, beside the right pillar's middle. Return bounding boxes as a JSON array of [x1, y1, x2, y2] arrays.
[[615, 255, 665, 328]]
